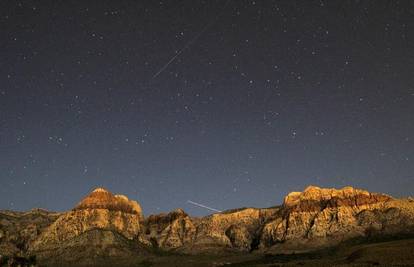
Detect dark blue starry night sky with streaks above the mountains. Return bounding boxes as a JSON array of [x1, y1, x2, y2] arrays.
[[0, 0, 414, 216]]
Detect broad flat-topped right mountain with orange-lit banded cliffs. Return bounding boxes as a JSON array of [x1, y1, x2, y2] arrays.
[[260, 186, 414, 253]]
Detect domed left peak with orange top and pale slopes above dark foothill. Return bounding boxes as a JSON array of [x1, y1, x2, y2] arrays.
[[30, 188, 143, 252]]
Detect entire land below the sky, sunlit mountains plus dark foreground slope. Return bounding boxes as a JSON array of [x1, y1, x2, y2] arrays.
[[0, 186, 414, 266]]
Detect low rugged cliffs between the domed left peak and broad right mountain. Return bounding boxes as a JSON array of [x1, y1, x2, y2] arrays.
[[145, 208, 277, 253]]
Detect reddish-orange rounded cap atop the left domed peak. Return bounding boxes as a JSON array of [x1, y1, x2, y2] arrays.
[[74, 188, 142, 217]]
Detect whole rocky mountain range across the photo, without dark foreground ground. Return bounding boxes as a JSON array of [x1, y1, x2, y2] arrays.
[[0, 186, 414, 261]]
